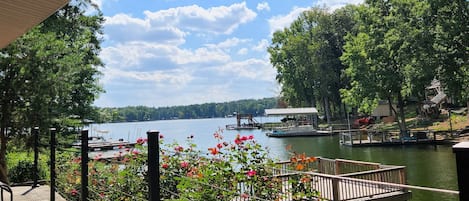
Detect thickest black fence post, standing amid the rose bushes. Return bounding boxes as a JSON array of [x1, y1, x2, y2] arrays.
[[147, 131, 160, 201]]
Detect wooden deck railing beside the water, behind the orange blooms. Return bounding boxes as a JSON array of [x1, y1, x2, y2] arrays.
[[268, 157, 408, 200]]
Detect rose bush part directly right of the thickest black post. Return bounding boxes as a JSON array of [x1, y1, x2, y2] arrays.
[[160, 129, 280, 200]]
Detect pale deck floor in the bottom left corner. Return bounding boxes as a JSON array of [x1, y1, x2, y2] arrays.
[[3, 185, 66, 201]]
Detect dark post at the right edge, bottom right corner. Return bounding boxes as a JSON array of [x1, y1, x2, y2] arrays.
[[453, 142, 469, 200]]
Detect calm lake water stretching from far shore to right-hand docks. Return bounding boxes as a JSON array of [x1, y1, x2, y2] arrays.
[[90, 118, 458, 201]]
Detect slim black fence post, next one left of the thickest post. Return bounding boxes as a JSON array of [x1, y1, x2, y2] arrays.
[[81, 130, 88, 201]]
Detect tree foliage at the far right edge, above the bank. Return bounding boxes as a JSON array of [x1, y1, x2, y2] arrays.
[[429, 0, 469, 112]]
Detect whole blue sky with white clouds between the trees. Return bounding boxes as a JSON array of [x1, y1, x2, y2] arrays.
[[94, 0, 362, 107]]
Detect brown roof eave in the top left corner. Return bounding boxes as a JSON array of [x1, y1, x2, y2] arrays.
[[0, 0, 69, 48]]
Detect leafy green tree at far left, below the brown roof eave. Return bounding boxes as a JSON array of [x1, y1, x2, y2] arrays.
[[0, 0, 103, 182]]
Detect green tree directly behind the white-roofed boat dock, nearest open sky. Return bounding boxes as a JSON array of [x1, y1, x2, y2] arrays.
[[268, 6, 354, 121]]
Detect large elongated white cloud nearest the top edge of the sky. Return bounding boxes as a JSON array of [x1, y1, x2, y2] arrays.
[[144, 2, 257, 34]]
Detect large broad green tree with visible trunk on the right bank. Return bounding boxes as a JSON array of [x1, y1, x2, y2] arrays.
[[341, 0, 435, 133]]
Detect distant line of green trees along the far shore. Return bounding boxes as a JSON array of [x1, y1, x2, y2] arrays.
[[98, 98, 277, 122]]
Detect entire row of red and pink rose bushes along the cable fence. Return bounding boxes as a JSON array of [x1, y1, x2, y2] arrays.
[[57, 129, 317, 200]]
